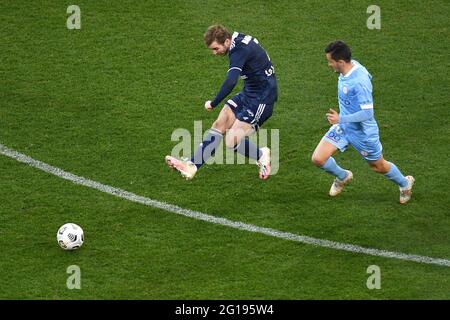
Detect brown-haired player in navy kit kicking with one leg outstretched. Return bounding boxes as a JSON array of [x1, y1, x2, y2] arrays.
[[165, 25, 278, 180]]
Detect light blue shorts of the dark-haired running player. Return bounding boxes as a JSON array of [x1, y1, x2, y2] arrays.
[[323, 124, 383, 161]]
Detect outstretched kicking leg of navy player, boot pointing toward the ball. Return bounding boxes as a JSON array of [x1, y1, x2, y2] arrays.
[[166, 105, 236, 179]]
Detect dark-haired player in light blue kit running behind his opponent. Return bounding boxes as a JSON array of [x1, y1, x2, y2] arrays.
[[312, 41, 414, 204]]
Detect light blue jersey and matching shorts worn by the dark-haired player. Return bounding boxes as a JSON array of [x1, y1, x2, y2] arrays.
[[324, 60, 382, 161]]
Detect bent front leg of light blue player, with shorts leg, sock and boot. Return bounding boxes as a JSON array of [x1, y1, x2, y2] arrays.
[[311, 125, 353, 197]]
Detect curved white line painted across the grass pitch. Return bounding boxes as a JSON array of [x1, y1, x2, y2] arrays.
[[0, 144, 450, 267]]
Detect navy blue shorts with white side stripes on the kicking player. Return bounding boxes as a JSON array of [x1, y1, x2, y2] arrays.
[[225, 92, 275, 131]]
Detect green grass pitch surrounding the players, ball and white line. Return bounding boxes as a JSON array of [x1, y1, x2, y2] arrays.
[[0, 0, 450, 299]]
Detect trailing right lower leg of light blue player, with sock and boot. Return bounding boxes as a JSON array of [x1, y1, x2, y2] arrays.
[[368, 155, 414, 204]]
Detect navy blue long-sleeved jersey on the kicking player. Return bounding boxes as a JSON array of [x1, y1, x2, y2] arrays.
[[211, 32, 277, 107]]
